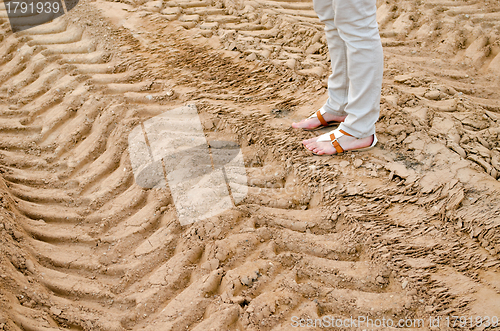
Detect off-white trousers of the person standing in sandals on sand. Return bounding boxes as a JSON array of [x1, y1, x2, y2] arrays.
[[313, 0, 384, 138]]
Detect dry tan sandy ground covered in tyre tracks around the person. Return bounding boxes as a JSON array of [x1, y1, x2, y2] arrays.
[[0, 0, 500, 331]]
